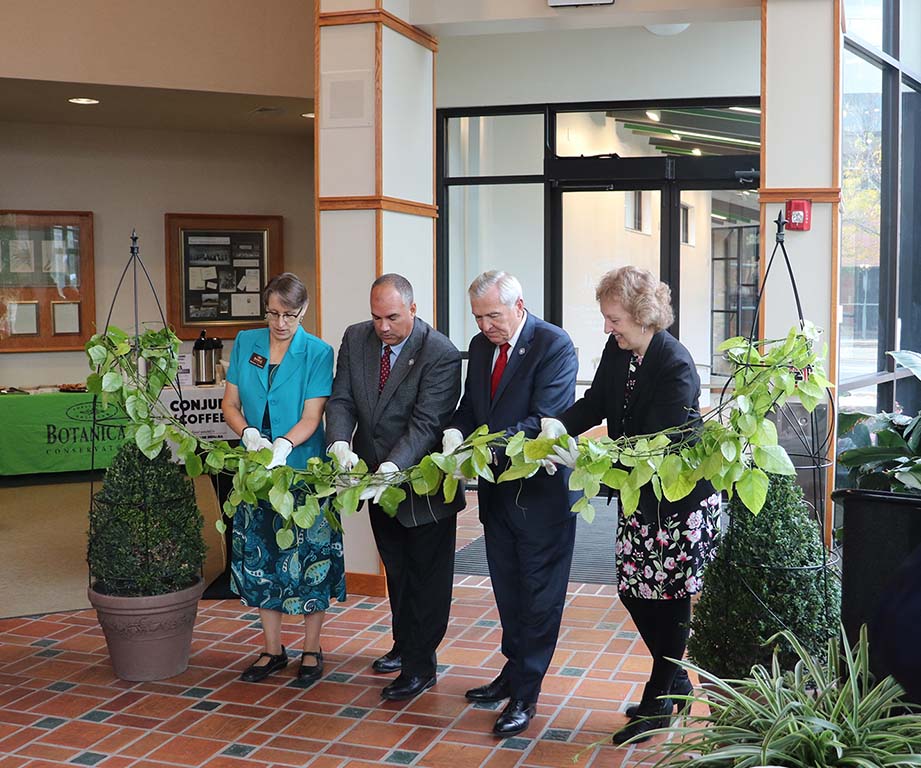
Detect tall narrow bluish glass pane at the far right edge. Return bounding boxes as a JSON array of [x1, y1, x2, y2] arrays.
[[899, 82, 921, 370]]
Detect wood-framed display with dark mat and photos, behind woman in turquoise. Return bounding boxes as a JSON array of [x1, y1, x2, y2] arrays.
[[166, 213, 284, 339]]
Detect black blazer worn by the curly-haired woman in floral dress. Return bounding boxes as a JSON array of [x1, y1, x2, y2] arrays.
[[558, 331, 713, 514]]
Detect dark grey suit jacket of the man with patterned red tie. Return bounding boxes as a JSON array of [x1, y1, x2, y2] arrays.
[[326, 318, 465, 527]]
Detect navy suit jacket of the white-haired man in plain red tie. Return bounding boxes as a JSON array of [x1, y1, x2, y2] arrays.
[[451, 312, 579, 524]]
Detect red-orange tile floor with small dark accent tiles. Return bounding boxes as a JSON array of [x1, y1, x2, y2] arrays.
[[0, 500, 696, 768]]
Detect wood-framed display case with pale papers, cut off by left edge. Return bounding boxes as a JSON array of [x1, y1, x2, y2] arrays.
[[0, 210, 96, 352]]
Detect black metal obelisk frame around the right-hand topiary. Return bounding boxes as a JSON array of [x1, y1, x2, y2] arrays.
[[720, 209, 840, 634]]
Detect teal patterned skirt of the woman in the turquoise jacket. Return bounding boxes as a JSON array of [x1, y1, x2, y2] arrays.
[[230, 490, 345, 614]]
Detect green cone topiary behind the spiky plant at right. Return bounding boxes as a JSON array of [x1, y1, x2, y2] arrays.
[[688, 475, 841, 679]]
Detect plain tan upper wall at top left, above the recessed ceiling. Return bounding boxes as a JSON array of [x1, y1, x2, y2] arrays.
[[0, 0, 314, 98]]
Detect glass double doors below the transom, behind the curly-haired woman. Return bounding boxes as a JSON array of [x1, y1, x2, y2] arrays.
[[557, 183, 760, 396]]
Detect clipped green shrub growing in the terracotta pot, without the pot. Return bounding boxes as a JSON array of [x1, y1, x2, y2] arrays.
[[87, 441, 205, 597]]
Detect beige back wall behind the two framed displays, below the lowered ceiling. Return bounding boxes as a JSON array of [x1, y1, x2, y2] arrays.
[[0, 122, 315, 386]]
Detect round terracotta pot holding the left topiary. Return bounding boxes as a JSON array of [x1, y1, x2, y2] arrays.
[[87, 578, 205, 681]]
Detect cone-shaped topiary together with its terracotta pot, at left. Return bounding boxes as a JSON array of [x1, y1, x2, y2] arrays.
[[87, 441, 205, 680]]
